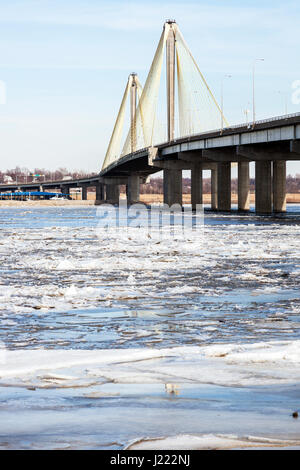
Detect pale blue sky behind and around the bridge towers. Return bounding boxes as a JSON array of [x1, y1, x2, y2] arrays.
[[0, 0, 300, 173]]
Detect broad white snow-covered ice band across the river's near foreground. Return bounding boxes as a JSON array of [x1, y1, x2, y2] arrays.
[[0, 340, 300, 386]]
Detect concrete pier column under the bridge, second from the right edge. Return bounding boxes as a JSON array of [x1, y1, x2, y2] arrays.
[[255, 161, 273, 214]]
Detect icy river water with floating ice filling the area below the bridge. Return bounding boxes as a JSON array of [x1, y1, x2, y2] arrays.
[[0, 205, 300, 449]]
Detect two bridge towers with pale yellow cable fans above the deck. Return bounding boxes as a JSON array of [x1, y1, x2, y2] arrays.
[[102, 20, 228, 176]]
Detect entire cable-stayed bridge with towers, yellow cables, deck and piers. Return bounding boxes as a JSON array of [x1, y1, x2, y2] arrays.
[[0, 20, 300, 214]]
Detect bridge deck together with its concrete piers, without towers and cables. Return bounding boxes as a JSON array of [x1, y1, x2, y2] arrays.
[[0, 114, 300, 214]]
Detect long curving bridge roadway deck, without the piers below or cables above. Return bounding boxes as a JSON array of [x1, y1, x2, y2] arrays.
[[0, 113, 300, 192]]
